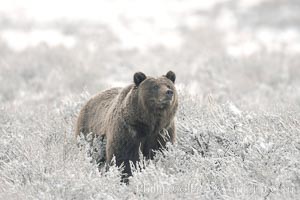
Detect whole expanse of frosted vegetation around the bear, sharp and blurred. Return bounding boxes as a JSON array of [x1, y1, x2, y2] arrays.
[[0, 1, 300, 199]]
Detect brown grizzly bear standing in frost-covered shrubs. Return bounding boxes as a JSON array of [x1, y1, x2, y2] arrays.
[[76, 71, 178, 181]]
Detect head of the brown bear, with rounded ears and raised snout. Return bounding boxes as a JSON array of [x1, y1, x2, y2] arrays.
[[133, 71, 177, 110]]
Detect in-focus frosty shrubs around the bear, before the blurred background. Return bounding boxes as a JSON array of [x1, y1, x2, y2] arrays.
[[0, 91, 300, 199]]
